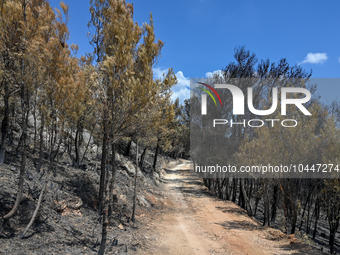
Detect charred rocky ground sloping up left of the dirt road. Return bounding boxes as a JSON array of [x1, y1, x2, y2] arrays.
[[0, 142, 176, 255]]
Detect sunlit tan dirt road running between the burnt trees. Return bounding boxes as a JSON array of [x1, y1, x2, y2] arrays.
[[139, 162, 319, 255]]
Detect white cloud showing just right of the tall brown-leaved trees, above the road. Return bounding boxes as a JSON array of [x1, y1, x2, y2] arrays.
[[153, 68, 190, 104]]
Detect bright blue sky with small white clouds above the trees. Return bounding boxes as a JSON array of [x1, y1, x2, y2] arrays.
[[50, 0, 340, 101]]
